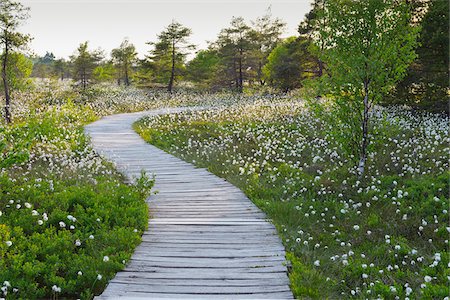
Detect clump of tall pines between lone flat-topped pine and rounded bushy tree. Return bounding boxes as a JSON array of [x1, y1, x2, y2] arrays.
[[187, 10, 286, 93]]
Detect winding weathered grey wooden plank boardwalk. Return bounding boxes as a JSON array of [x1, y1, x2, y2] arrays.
[[86, 110, 293, 299]]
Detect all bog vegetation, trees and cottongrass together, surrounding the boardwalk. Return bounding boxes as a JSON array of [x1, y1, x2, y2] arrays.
[[0, 0, 450, 299]]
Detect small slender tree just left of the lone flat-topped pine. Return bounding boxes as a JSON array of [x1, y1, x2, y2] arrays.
[[111, 39, 137, 86]]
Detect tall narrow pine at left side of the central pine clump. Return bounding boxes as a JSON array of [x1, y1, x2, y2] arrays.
[[216, 17, 254, 93]]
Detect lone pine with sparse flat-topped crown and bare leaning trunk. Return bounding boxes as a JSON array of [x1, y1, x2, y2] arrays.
[[149, 21, 195, 92]]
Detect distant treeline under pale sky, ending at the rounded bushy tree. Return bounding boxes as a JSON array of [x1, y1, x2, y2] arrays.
[[32, 10, 323, 92]]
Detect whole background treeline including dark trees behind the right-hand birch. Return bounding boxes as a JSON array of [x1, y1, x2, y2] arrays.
[[3, 0, 449, 111]]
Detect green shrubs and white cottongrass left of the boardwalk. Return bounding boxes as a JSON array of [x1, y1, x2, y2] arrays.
[[0, 90, 153, 299]]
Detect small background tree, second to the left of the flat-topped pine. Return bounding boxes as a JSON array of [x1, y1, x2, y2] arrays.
[[70, 42, 103, 90]]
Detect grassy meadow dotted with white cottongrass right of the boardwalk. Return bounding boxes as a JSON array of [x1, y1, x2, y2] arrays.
[[135, 103, 450, 299]]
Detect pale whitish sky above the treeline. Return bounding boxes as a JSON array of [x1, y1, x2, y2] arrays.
[[21, 0, 311, 58]]
